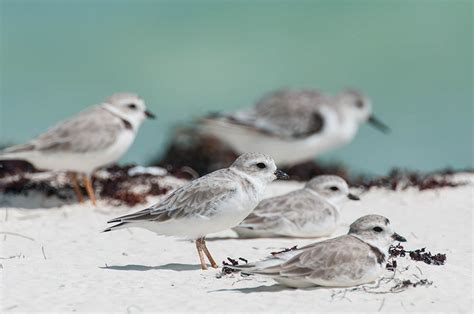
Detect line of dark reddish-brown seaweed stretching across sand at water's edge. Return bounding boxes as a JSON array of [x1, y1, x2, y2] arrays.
[[0, 132, 474, 206]]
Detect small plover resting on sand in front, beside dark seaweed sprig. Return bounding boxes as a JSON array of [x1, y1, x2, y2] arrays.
[[230, 215, 406, 288]]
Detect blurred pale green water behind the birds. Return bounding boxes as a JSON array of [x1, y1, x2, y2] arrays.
[[0, 0, 473, 174]]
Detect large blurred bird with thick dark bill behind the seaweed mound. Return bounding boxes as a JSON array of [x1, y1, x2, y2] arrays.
[[200, 89, 389, 165]]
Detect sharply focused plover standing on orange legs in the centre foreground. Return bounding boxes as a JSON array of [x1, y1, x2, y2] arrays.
[[104, 153, 288, 269]]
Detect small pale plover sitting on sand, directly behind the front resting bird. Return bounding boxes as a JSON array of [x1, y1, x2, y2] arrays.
[[233, 175, 359, 238]]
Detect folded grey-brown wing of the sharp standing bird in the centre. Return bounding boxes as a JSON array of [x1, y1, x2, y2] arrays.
[[109, 173, 238, 223]]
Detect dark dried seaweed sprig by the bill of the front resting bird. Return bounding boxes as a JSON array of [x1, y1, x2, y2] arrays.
[[386, 243, 446, 271]]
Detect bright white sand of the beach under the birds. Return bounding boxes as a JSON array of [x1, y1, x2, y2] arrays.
[[0, 175, 474, 313]]
